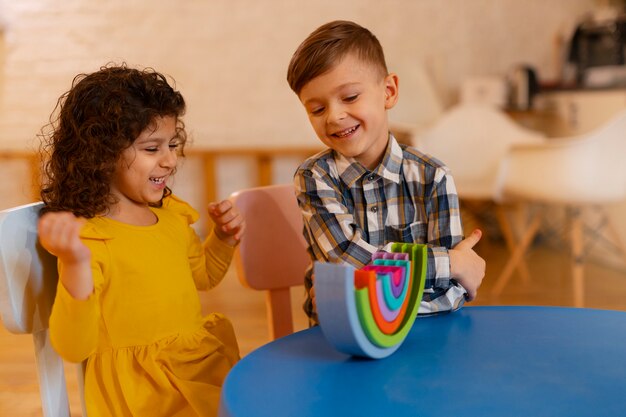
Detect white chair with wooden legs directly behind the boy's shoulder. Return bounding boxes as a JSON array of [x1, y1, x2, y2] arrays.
[[415, 103, 545, 281]]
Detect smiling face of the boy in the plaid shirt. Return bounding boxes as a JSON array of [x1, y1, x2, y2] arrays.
[[299, 54, 398, 170]]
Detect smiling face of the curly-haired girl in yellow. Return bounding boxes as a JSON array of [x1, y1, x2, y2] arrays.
[[111, 116, 179, 217]]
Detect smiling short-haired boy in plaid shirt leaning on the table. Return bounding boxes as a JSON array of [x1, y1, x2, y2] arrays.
[[287, 21, 485, 324]]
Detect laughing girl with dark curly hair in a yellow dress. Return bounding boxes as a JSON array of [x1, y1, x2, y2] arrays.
[[39, 65, 244, 417]]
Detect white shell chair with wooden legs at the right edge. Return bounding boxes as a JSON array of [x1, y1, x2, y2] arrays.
[[493, 111, 626, 307]]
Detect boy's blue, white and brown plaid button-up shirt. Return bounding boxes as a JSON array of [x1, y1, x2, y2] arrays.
[[294, 134, 465, 323]]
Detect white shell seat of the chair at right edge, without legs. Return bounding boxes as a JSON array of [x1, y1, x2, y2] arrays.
[[501, 110, 626, 204]]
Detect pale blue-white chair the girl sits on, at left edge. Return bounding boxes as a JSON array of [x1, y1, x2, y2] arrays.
[[0, 203, 87, 417]]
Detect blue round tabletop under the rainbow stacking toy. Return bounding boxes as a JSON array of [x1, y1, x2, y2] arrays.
[[219, 307, 626, 417]]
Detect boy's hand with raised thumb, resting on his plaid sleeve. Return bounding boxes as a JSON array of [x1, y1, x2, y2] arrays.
[[448, 229, 485, 301]]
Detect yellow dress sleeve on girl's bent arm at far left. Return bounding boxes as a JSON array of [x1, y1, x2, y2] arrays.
[[49, 227, 107, 363]]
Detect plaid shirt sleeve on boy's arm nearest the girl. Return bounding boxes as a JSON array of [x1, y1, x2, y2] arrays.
[[294, 170, 377, 268]]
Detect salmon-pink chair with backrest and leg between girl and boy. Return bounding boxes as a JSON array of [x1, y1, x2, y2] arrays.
[[230, 184, 311, 339]]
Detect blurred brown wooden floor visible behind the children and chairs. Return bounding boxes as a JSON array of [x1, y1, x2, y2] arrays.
[[0, 242, 626, 417]]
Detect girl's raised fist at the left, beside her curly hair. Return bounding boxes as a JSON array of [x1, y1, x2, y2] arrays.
[[38, 212, 91, 264]]
